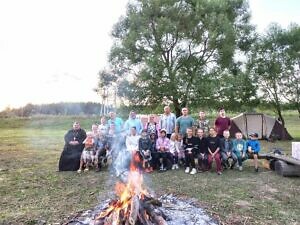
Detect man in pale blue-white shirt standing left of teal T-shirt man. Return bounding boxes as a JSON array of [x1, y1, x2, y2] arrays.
[[159, 106, 176, 138]]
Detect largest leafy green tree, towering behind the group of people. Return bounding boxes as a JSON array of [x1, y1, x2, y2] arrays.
[[104, 0, 253, 115]]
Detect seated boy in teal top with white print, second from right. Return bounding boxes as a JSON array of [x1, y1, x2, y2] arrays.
[[232, 132, 248, 171]]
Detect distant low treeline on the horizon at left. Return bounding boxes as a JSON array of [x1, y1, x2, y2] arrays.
[[0, 102, 111, 117]]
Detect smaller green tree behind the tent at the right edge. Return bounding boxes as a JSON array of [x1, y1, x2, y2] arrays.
[[248, 24, 299, 126]]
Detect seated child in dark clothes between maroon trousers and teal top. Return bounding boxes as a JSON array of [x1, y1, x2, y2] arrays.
[[221, 130, 237, 169]]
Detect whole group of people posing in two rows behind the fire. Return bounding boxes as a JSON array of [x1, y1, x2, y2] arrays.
[[59, 106, 260, 175]]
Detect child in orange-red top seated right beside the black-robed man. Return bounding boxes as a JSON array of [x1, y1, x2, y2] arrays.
[[77, 132, 94, 173]]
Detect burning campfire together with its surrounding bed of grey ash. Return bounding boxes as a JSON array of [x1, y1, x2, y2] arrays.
[[64, 152, 218, 225]]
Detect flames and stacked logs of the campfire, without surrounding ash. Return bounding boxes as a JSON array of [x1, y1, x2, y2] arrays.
[[96, 155, 167, 225]]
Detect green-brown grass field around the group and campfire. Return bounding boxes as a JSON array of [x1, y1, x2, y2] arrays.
[[0, 115, 300, 225]]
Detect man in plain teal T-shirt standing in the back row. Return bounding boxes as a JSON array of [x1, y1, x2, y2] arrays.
[[175, 107, 194, 136]]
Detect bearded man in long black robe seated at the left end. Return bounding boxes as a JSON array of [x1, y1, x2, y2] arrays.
[[58, 121, 86, 171]]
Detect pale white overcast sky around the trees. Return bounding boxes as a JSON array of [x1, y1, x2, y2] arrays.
[[0, 0, 300, 110]]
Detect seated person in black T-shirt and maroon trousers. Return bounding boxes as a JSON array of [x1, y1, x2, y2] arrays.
[[207, 127, 222, 175]]
